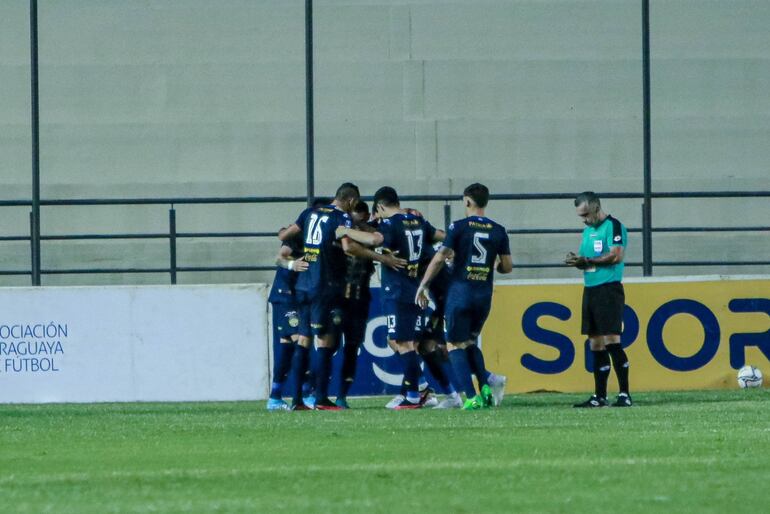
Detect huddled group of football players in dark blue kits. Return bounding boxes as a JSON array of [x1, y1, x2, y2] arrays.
[[267, 183, 513, 410]]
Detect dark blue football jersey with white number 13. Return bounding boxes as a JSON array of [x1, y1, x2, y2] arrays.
[[378, 213, 436, 303]]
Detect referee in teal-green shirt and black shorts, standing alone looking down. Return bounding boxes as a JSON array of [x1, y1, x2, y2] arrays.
[[564, 191, 632, 408]]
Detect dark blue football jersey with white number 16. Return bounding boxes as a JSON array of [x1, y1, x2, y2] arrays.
[[295, 205, 352, 294]]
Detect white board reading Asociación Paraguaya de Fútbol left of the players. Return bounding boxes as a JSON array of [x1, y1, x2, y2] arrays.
[[0, 284, 269, 403]]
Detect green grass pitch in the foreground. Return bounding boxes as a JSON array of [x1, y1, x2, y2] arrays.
[[0, 390, 770, 514]]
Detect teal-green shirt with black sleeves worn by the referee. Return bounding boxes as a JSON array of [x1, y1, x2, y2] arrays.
[[580, 216, 628, 287]]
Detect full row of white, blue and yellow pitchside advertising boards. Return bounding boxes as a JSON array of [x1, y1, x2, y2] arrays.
[[0, 277, 770, 403]]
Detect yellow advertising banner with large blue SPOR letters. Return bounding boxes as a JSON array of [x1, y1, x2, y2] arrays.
[[481, 277, 770, 392]]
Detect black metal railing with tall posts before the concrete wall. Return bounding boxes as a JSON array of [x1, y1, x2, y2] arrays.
[[7, 0, 770, 285]]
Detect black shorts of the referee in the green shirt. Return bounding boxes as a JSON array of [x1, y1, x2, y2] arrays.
[[581, 282, 626, 336]]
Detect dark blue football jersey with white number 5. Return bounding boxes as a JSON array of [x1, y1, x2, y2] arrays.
[[444, 216, 511, 294]]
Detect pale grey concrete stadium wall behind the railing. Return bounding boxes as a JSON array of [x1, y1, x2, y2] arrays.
[[0, 0, 770, 285]]
